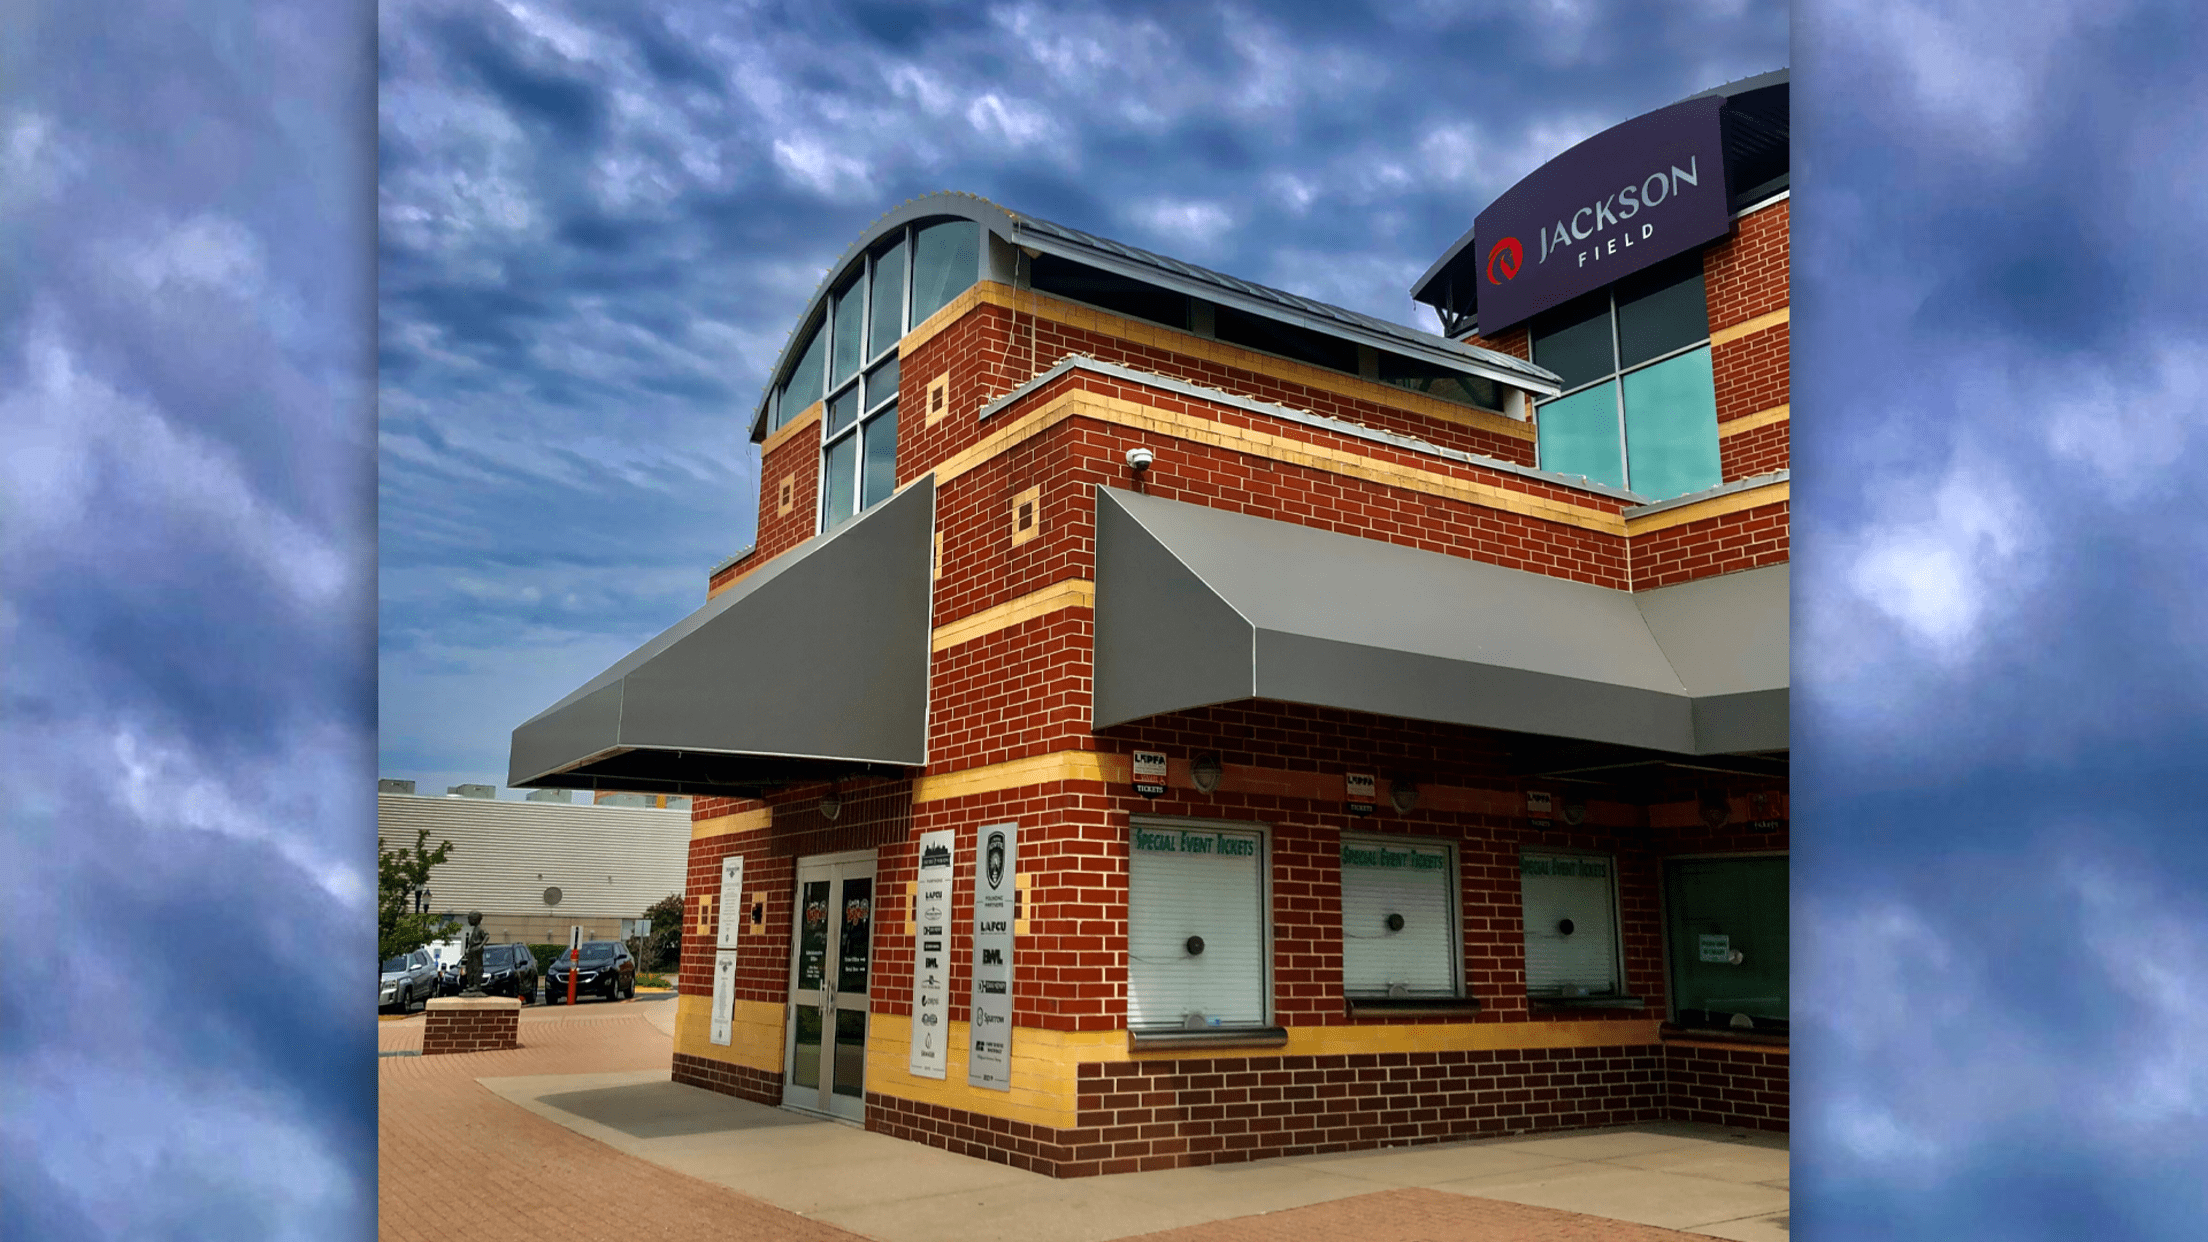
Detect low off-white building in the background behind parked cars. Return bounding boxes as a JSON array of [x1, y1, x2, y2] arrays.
[[375, 780, 691, 944]]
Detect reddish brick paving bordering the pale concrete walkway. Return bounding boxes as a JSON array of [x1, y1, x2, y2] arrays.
[[378, 1003, 1757, 1242]]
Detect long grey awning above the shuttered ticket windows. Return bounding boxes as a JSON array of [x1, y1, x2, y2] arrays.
[[1093, 488, 1788, 754]]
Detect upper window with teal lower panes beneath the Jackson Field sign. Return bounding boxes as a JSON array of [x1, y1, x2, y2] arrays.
[[1532, 254, 1724, 499]]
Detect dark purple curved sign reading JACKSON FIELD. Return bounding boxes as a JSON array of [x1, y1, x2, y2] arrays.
[[1473, 99, 1731, 336]]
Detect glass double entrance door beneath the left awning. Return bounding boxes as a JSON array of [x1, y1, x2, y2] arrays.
[[782, 851, 874, 1120]]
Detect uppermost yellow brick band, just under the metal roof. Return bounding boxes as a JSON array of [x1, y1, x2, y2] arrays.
[[896, 281, 1535, 440]]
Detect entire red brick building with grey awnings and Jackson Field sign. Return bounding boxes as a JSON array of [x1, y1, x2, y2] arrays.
[[510, 73, 1788, 1176]]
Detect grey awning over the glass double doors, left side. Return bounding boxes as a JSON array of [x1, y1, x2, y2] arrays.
[[506, 475, 936, 793]]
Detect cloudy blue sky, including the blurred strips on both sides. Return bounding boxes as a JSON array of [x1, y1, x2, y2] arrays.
[[0, 0, 2208, 1240]]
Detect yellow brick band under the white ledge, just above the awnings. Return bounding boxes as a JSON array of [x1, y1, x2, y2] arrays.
[[936, 389, 1625, 535]]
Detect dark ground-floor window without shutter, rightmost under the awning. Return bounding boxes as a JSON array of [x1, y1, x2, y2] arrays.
[[1665, 855, 1791, 1030]]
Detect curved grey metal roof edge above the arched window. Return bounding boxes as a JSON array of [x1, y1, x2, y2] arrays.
[[751, 190, 1557, 440]]
